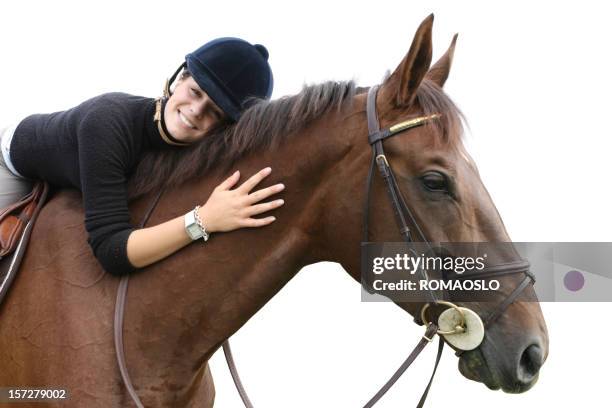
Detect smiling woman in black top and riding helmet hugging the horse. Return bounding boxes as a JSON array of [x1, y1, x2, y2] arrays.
[[0, 38, 284, 275]]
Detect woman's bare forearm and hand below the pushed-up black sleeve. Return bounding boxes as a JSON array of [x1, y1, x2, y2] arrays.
[[127, 167, 284, 268]]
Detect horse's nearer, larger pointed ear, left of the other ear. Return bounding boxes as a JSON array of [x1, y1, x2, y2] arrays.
[[383, 14, 433, 107]]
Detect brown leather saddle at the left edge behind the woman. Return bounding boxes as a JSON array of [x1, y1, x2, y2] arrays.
[[0, 181, 49, 304]]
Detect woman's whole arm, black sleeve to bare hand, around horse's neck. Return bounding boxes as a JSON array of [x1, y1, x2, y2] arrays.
[[77, 103, 280, 276]]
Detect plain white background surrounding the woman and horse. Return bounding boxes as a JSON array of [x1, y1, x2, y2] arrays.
[[0, 0, 612, 408]]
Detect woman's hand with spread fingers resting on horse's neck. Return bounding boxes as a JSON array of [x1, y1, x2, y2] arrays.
[[199, 167, 285, 232]]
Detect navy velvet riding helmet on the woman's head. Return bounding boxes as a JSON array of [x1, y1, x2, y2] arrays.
[[166, 37, 274, 121]]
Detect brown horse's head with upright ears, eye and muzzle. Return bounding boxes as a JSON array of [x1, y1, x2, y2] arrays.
[[334, 16, 548, 392]]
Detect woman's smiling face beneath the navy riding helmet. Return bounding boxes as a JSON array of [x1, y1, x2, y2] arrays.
[[164, 76, 225, 143]]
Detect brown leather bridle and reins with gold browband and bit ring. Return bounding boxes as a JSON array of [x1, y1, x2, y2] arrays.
[[114, 86, 535, 408]]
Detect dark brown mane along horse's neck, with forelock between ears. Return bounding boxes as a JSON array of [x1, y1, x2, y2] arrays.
[[128, 80, 463, 200]]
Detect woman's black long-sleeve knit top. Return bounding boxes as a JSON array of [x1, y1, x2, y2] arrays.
[[10, 93, 171, 275]]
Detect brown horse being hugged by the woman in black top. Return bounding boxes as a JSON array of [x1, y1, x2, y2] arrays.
[[0, 16, 548, 407]]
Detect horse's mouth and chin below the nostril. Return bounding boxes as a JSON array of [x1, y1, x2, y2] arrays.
[[459, 349, 538, 394]]
